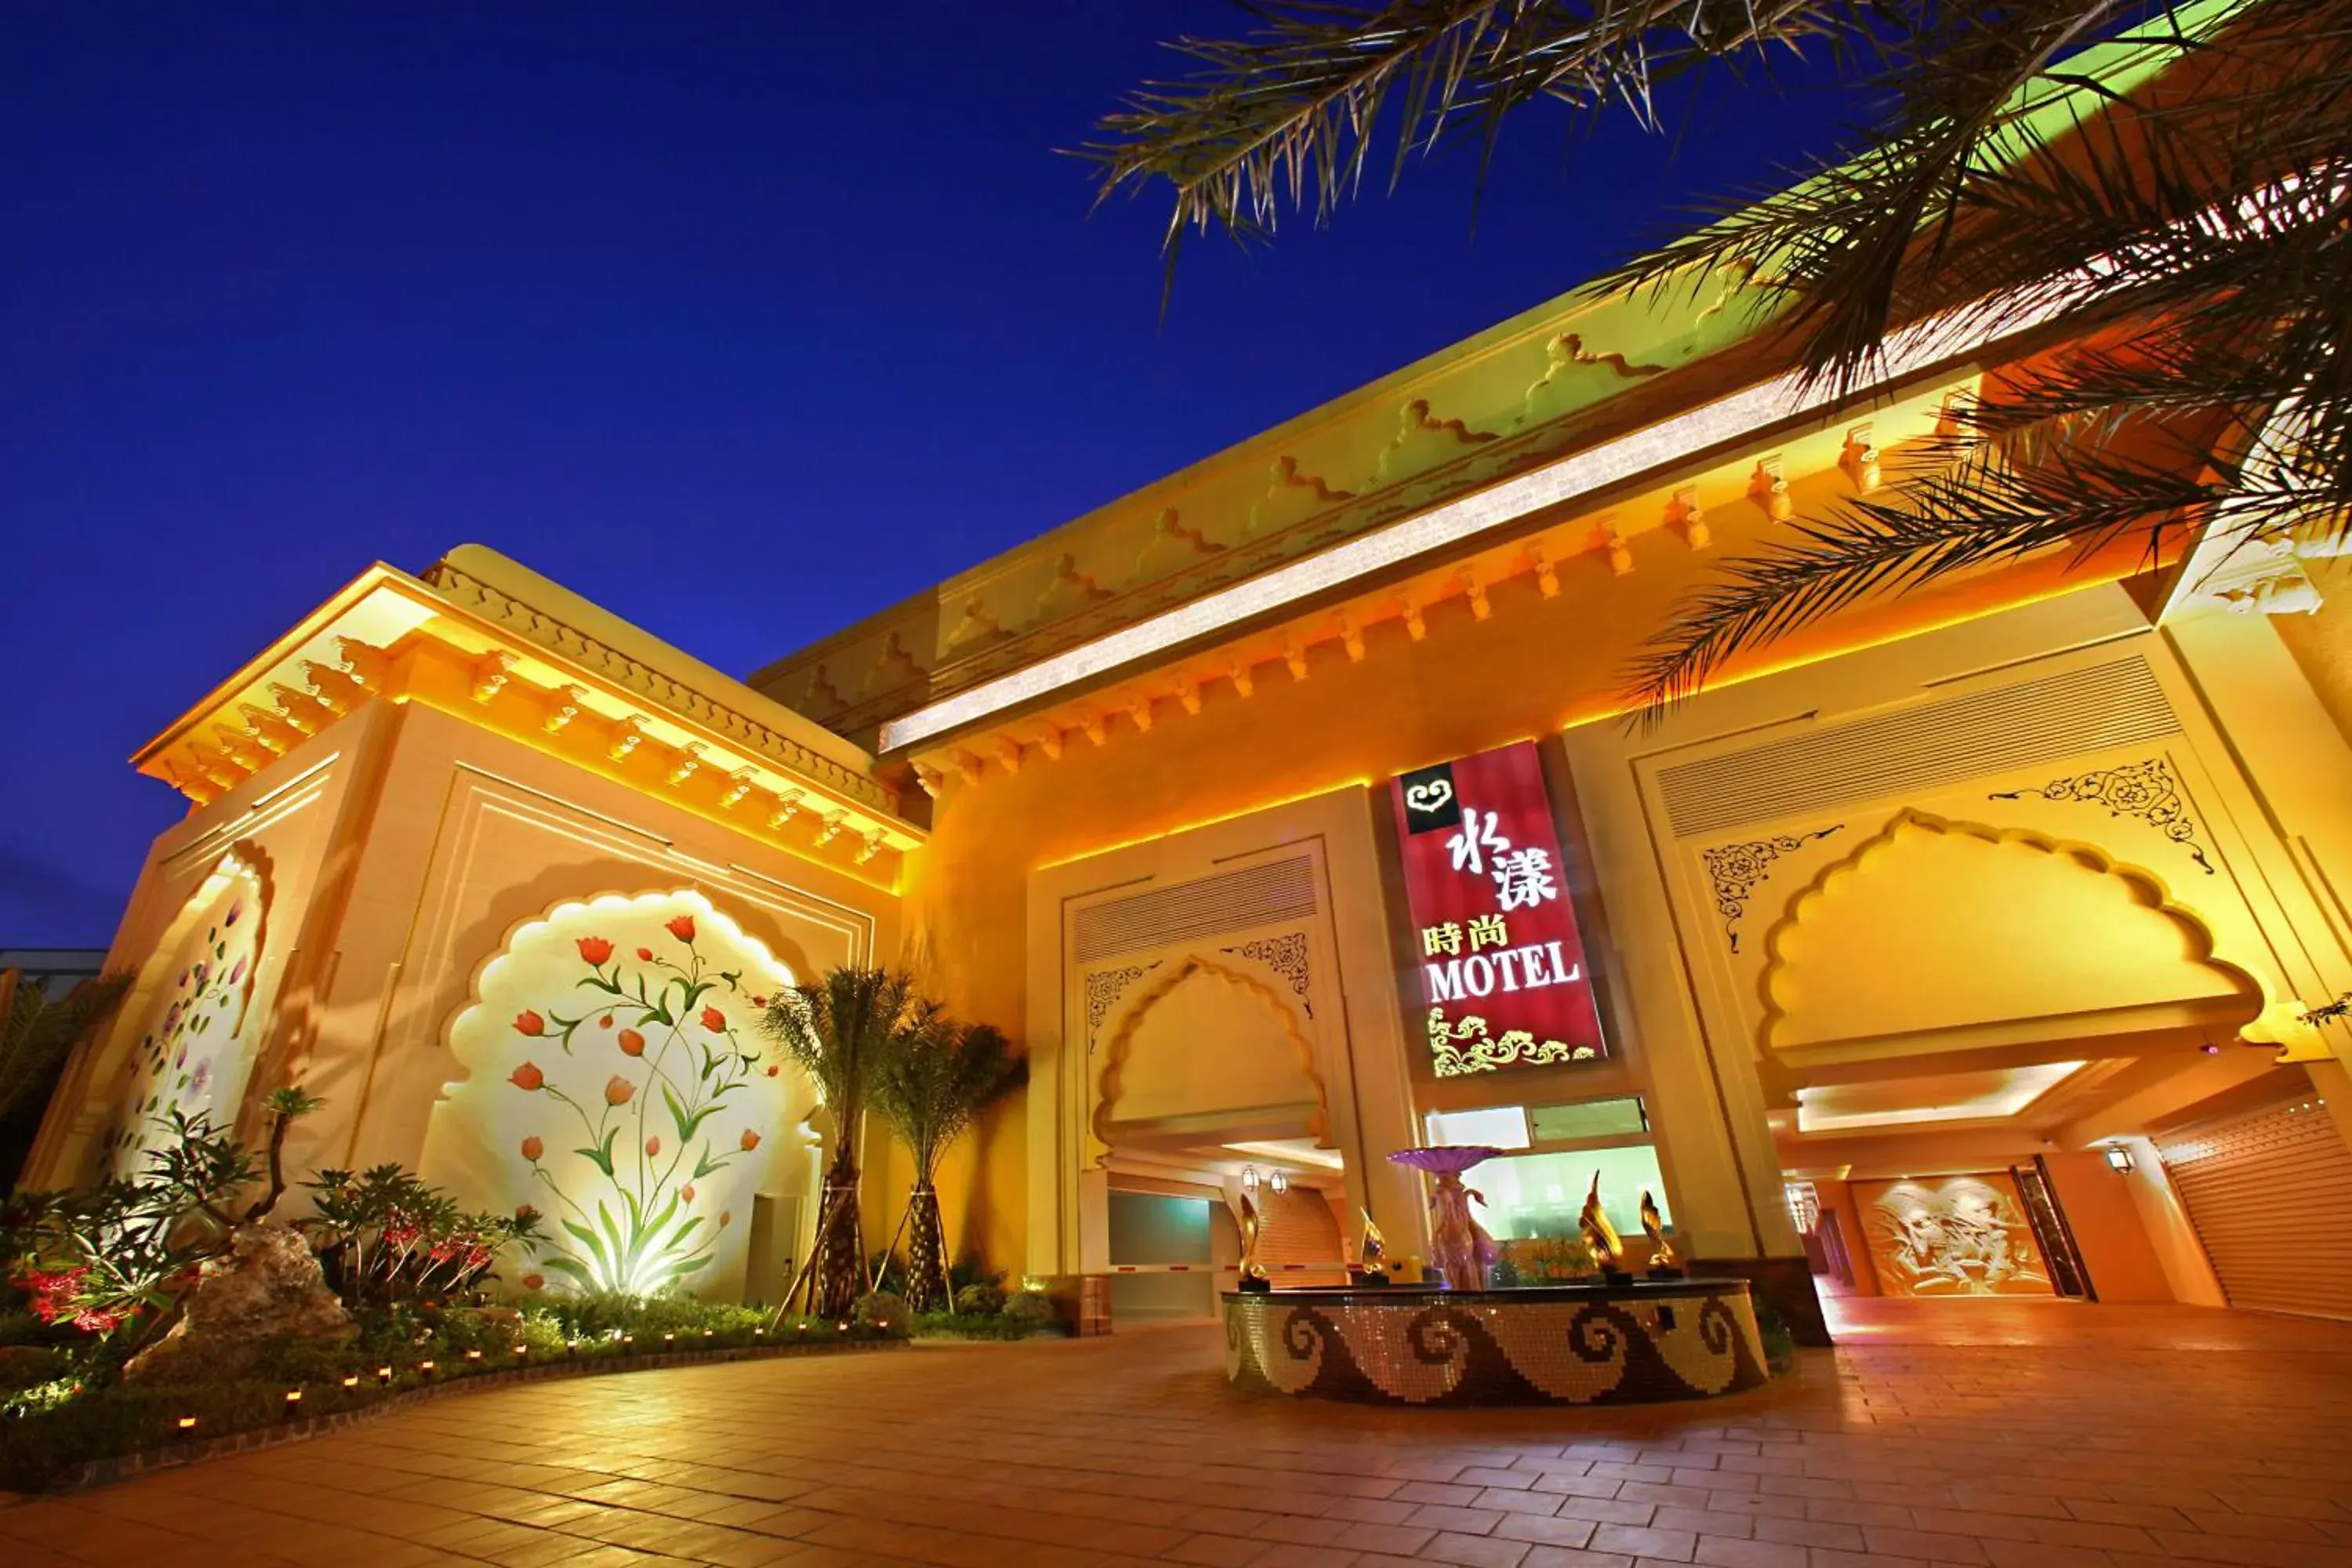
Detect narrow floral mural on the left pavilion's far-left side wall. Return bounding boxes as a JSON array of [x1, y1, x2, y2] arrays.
[[99, 855, 266, 1178]]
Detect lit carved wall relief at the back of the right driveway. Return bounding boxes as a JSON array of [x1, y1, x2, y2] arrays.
[[1853, 1171, 2051, 1295]]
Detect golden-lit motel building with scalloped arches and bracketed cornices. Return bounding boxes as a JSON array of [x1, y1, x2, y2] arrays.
[[26, 36, 2352, 1340]]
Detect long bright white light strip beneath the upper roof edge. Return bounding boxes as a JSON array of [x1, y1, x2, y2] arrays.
[[880, 305, 2074, 753]]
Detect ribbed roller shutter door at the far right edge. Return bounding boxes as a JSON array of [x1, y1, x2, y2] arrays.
[[2157, 1095, 2352, 1319]]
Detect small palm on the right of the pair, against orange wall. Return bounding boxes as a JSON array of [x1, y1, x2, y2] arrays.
[[873, 1018, 1028, 1312]]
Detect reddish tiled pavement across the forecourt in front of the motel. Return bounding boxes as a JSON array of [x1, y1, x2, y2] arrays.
[[0, 1302, 2352, 1568]]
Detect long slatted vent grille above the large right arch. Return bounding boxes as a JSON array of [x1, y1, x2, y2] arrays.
[[1658, 656, 2180, 837]]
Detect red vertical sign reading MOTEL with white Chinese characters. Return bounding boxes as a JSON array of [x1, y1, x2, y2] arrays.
[[1390, 743, 1602, 1076]]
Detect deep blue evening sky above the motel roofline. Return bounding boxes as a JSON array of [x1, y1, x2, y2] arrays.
[[0, 0, 1832, 945]]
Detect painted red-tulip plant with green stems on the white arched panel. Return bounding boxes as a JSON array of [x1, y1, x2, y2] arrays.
[[501, 905, 774, 1295]]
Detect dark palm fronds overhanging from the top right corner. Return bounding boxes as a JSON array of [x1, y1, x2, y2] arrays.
[[1087, 0, 2352, 713]]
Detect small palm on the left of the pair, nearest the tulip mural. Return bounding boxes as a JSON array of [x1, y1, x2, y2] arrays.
[[762, 966, 938, 1319]]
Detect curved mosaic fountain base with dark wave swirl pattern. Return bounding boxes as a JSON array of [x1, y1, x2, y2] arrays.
[[1225, 1279, 1769, 1406]]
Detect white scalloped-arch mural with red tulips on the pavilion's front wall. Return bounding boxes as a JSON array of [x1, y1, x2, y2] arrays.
[[423, 893, 816, 1298]]
